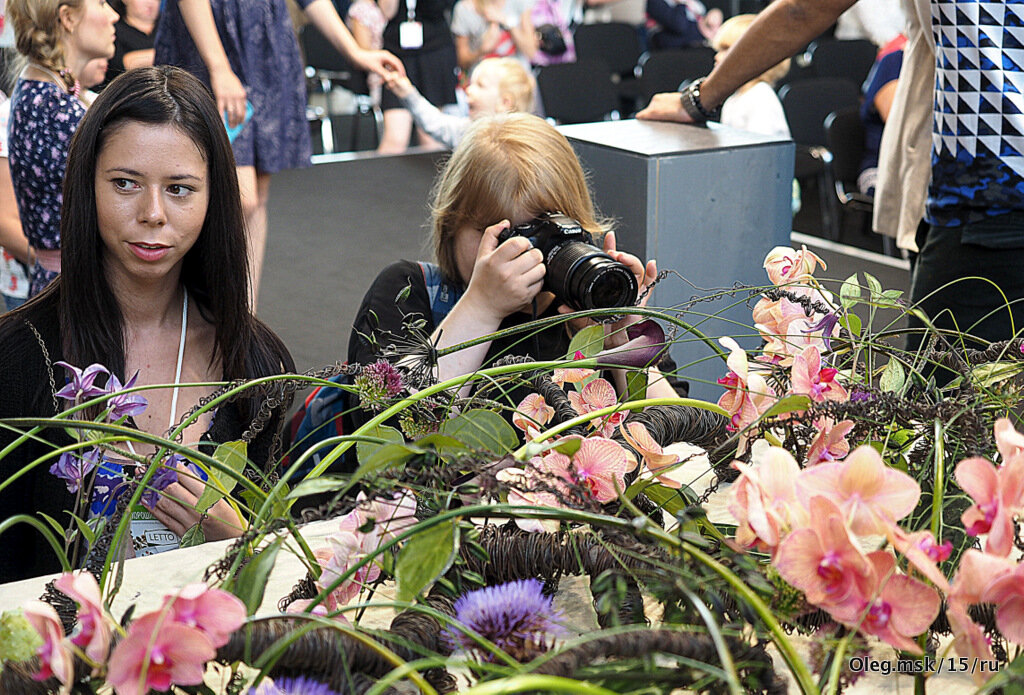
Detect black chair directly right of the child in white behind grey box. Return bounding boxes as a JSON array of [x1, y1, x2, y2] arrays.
[[778, 78, 860, 240]]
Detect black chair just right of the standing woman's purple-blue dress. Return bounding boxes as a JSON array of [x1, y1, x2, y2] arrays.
[[299, 25, 384, 153]]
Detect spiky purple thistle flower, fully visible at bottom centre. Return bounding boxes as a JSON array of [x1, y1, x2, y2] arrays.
[[443, 579, 563, 662]]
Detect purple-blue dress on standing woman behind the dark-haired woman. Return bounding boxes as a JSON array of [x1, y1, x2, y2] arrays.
[[156, 0, 312, 174]]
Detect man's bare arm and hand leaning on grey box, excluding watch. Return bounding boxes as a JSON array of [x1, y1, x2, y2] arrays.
[[637, 0, 856, 123]]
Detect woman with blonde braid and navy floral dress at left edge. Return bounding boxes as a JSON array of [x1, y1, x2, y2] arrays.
[[7, 0, 118, 297]]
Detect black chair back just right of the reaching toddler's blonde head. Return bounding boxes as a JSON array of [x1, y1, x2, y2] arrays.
[[537, 58, 618, 123]]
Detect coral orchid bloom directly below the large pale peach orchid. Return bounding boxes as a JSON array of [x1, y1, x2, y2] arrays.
[[774, 497, 872, 614]]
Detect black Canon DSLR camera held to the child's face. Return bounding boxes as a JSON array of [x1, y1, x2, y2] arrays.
[[498, 213, 637, 311]]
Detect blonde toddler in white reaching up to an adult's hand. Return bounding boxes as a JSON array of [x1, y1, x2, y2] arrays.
[[387, 58, 536, 149]]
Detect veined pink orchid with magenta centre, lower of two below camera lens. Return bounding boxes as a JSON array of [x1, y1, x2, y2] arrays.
[[543, 436, 637, 504]]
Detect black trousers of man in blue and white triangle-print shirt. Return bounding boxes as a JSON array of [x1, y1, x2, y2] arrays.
[[907, 213, 1024, 349]]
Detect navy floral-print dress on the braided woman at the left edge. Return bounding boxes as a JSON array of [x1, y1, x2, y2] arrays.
[[7, 79, 85, 297]]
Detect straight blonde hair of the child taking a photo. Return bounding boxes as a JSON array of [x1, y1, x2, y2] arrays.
[[432, 114, 608, 281]]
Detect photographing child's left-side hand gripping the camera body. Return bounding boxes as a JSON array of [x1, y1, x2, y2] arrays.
[[466, 220, 545, 323]]
